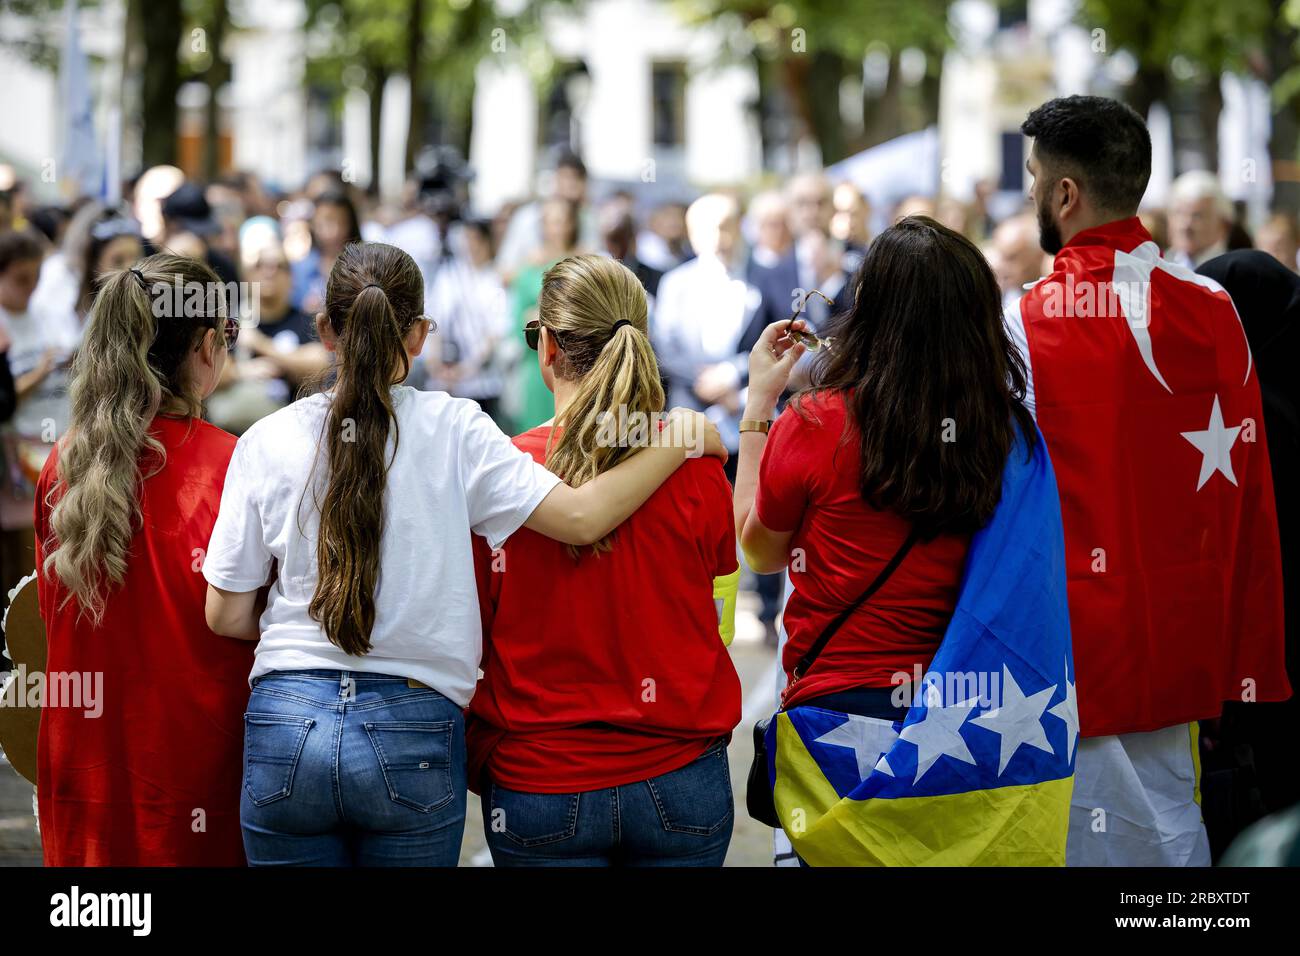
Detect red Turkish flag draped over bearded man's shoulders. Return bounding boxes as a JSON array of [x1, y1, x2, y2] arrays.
[[1019, 219, 1291, 736]]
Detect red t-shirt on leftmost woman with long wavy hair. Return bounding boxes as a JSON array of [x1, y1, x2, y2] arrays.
[[35, 418, 254, 866]]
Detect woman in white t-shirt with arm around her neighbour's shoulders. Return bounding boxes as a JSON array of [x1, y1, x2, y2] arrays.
[[204, 243, 729, 866]]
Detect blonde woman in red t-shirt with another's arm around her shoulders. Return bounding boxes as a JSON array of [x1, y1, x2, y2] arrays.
[[468, 256, 741, 866]]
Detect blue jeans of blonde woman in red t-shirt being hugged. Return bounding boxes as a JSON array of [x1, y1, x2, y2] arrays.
[[482, 741, 736, 866]]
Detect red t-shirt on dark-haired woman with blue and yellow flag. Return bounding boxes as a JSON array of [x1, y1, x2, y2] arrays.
[[755, 392, 970, 704]]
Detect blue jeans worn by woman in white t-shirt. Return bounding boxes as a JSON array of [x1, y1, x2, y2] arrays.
[[239, 670, 465, 866]]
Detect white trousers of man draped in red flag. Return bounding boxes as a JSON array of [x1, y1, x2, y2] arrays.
[[1065, 723, 1210, 866]]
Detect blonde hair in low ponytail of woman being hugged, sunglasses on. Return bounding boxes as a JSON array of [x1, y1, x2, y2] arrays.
[[538, 255, 664, 553]]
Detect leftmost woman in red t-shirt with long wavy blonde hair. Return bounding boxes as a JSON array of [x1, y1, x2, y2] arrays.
[[35, 255, 252, 866]]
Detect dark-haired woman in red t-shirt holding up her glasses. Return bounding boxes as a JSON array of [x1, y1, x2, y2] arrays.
[[735, 216, 1036, 719]]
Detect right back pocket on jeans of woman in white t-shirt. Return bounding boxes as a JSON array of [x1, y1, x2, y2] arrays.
[[364, 721, 455, 813]]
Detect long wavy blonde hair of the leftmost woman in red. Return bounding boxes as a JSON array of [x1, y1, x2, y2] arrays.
[[43, 255, 225, 626]]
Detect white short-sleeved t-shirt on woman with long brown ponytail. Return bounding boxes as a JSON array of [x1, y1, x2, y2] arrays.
[[203, 385, 559, 706]]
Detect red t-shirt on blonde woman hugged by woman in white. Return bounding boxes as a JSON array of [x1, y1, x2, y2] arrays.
[[467, 425, 741, 793]]
